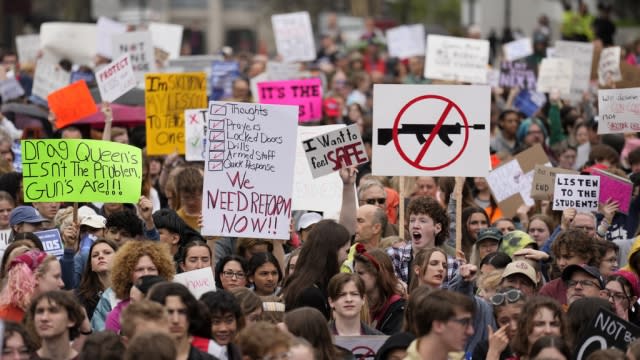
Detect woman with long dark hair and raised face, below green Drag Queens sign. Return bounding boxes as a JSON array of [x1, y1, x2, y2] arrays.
[[74, 239, 118, 319]]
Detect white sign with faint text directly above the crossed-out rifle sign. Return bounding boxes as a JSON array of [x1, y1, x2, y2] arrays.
[[424, 35, 489, 84]]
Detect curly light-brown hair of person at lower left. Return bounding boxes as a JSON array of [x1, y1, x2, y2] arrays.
[[111, 240, 176, 299]]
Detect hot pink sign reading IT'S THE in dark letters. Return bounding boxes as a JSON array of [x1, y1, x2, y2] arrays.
[[258, 78, 322, 123]]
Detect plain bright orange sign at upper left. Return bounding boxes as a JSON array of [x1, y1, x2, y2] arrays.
[[47, 80, 98, 129]]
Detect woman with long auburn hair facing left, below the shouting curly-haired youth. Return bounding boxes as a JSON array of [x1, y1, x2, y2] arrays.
[[354, 244, 405, 335]]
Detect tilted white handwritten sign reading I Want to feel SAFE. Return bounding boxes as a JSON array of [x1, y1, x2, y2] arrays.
[[302, 124, 369, 178]]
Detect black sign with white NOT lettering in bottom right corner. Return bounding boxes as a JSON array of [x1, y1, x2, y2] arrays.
[[574, 307, 640, 360]]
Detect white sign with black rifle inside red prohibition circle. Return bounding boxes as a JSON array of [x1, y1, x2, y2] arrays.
[[372, 85, 491, 177]]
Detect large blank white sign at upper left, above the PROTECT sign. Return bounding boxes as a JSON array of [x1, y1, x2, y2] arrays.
[[40, 22, 97, 65]]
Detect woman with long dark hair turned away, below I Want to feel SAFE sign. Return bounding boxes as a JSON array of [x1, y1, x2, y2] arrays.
[[282, 220, 350, 320]]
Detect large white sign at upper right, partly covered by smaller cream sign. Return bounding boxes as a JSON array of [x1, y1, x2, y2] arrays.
[[553, 40, 593, 99]]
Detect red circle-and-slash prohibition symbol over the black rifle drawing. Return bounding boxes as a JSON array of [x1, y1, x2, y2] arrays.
[[392, 95, 469, 171]]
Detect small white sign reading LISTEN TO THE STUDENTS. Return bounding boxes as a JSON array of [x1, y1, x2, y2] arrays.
[[553, 174, 600, 211]]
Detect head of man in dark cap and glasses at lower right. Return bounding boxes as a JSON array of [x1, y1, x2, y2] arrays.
[[562, 264, 607, 305]]
